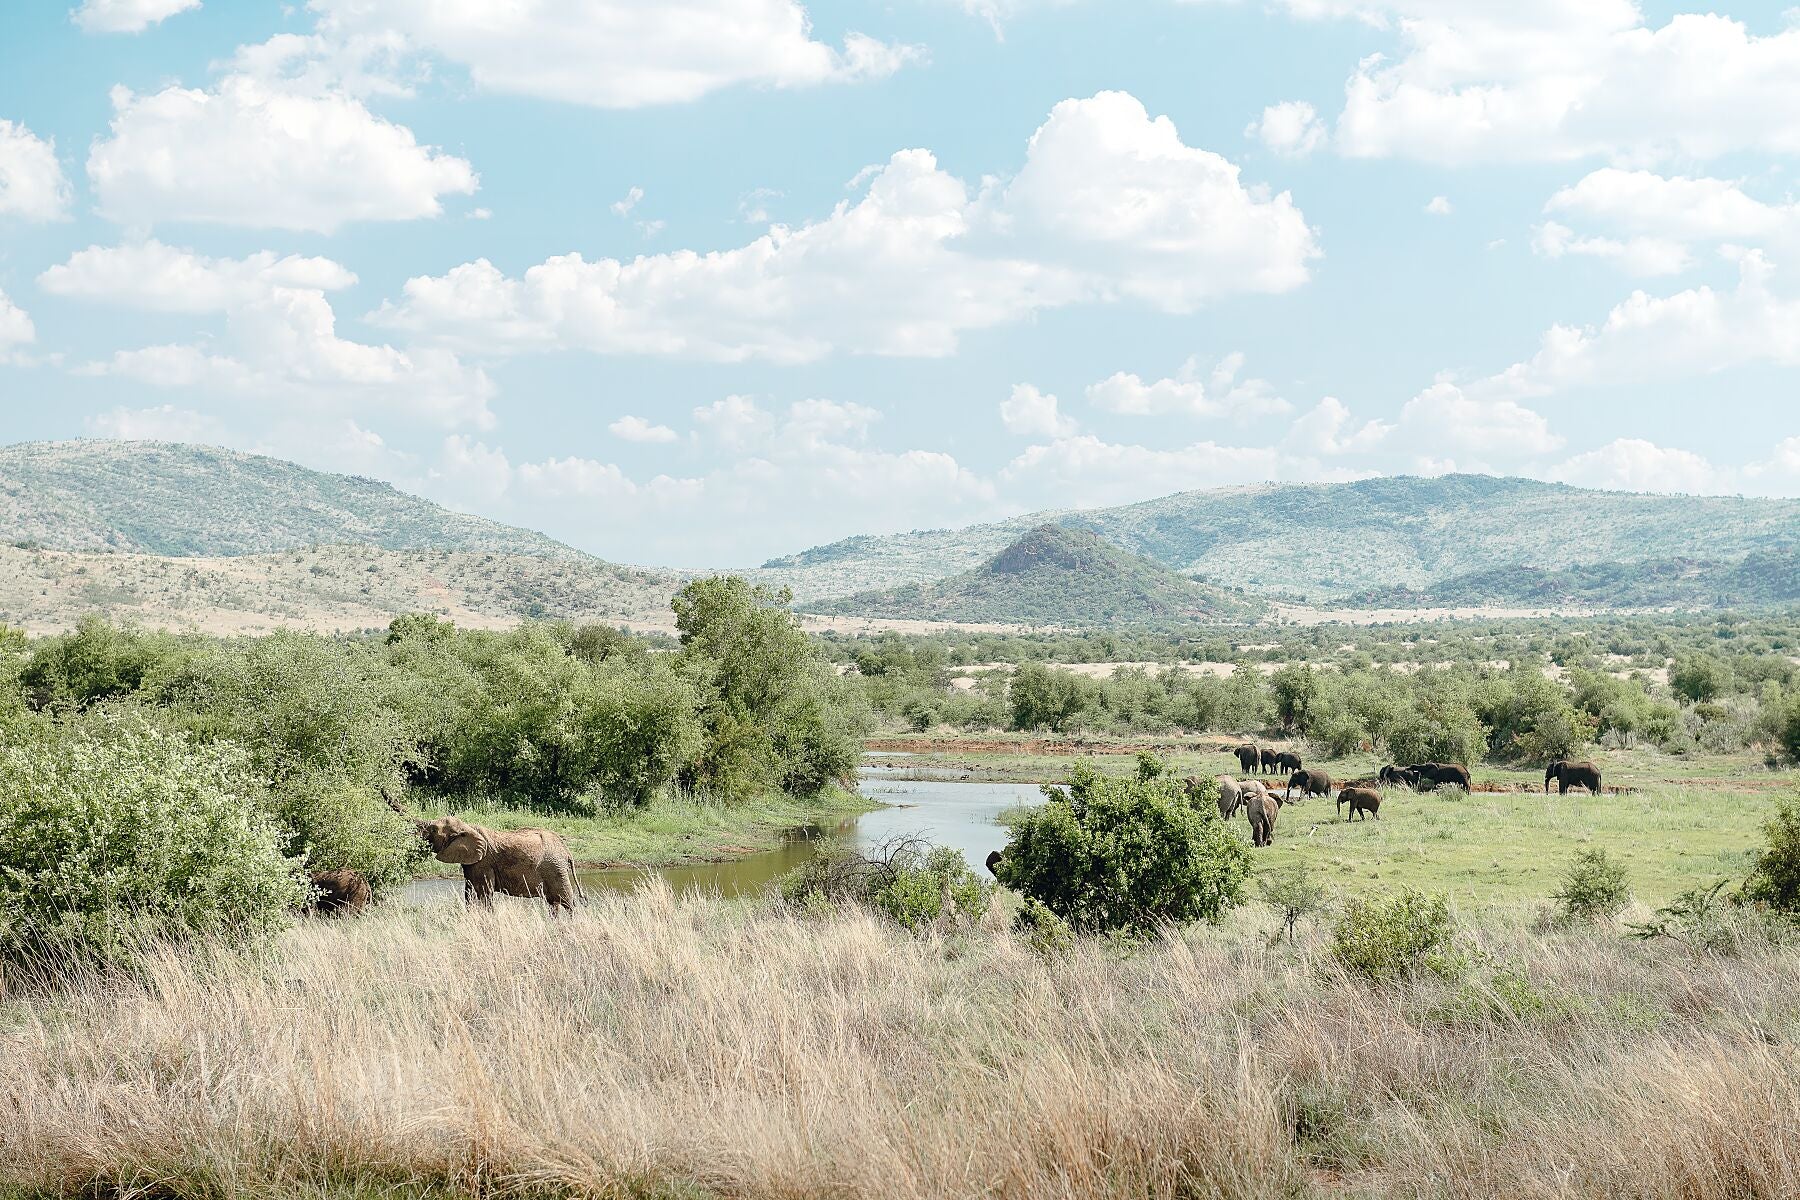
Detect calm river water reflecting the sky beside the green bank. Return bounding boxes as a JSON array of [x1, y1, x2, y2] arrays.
[[403, 768, 1044, 903]]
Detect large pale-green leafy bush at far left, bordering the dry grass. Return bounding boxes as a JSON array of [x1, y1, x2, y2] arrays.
[[0, 720, 306, 963]]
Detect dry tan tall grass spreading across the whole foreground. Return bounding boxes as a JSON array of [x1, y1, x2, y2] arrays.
[[0, 885, 1800, 1200]]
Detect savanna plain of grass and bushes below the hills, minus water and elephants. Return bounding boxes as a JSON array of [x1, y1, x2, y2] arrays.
[[0, 600, 1800, 1200]]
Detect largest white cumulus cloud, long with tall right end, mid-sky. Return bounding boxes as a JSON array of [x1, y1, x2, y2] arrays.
[[376, 94, 1318, 362]]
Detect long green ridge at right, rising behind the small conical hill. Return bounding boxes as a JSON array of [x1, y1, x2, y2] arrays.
[[761, 475, 1800, 603]]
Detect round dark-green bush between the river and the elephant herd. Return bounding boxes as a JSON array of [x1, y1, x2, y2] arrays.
[[997, 763, 1249, 936]]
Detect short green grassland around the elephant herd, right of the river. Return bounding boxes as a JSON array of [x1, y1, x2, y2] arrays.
[[878, 736, 1800, 909]]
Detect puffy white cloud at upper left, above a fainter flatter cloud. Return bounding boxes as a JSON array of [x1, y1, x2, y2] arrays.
[[88, 76, 475, 234]]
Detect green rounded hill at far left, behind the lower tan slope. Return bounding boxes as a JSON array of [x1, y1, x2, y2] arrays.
[[0, 441, 587, 560]]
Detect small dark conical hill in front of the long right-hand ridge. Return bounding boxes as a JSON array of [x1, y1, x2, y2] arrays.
[[799, 524, 1265, 626]]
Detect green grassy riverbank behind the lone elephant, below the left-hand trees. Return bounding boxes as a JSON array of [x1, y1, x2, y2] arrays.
[[421, 788, 873, 874]]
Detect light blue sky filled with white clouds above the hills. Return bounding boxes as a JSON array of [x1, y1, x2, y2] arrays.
[[0, 0, 1800, 565]]
